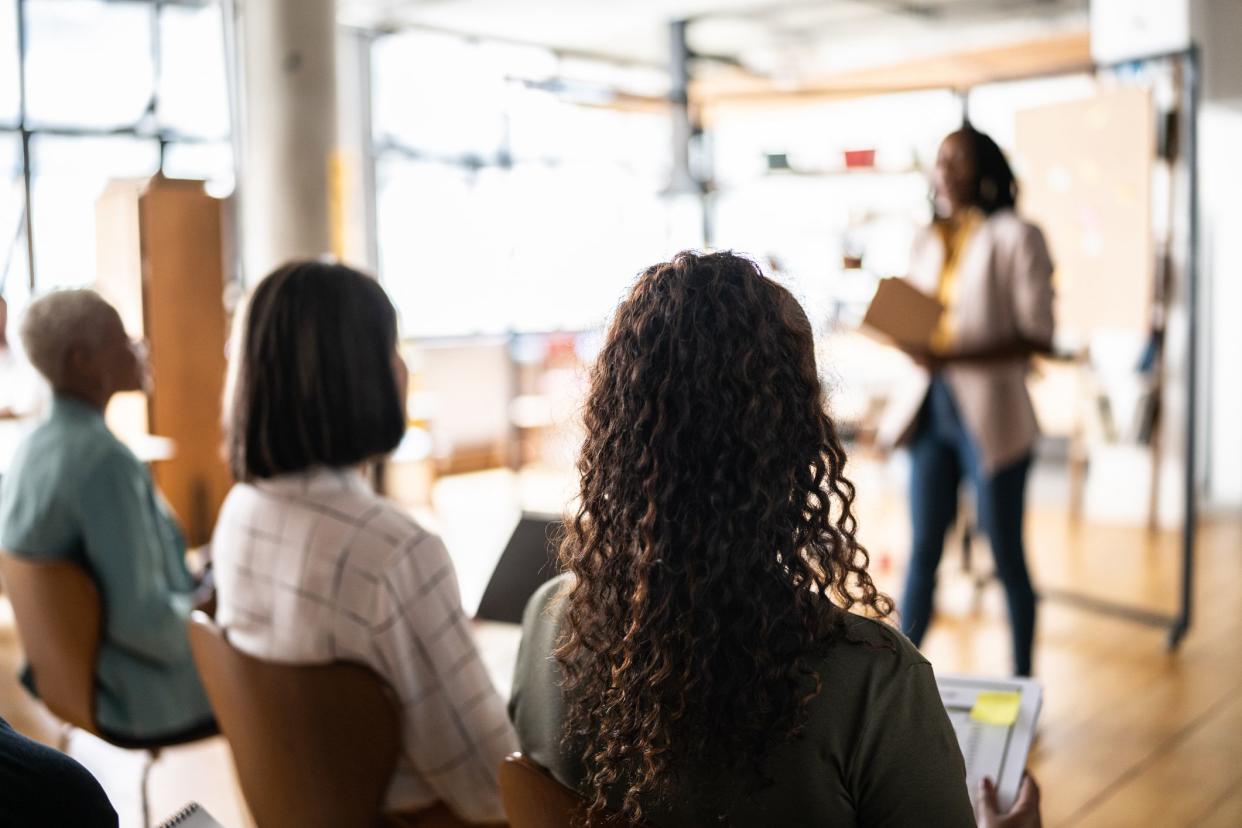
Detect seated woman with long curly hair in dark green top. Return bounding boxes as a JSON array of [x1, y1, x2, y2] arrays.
[[509, 252, 1033, 827]]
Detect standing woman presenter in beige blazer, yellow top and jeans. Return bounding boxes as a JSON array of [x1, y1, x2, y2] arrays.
[[883, 124, 1053, 675]]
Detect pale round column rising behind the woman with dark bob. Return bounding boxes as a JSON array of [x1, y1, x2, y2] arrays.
[[238, 0, 337, 283]]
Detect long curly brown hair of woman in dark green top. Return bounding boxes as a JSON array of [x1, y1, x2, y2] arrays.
[[555, 252, 892, 822]]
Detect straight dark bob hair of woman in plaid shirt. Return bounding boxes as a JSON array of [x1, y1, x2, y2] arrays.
[[227, 261, 405, 480]]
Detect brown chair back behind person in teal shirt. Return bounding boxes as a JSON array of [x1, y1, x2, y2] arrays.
[[0, 551, 103, 734]]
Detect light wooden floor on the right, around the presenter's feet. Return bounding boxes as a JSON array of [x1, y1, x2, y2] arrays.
[[924, 516, 1242, 826]]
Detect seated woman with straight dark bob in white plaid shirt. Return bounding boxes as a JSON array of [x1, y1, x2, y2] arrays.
[[212, 262, 517, 824]]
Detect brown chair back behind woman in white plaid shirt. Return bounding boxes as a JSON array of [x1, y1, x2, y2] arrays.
[[190, 612, 401, 828]]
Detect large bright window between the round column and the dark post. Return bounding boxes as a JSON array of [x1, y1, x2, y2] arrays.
[[371, 31, 702, 338]]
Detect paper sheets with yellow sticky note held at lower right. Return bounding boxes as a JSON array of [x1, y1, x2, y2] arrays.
[[936, 675, 1043, 811]]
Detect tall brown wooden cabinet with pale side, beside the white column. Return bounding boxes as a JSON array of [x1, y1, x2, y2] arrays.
[[96, 178, 231, 546]]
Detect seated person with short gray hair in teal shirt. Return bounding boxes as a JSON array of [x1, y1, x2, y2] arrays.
[[0, 290, 212, 741]]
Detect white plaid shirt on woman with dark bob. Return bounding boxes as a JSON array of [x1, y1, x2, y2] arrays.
[[211, 469, 518, 822]]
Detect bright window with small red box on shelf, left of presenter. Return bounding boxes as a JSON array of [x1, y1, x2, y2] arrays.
[[713, 91, 961, 323]]
